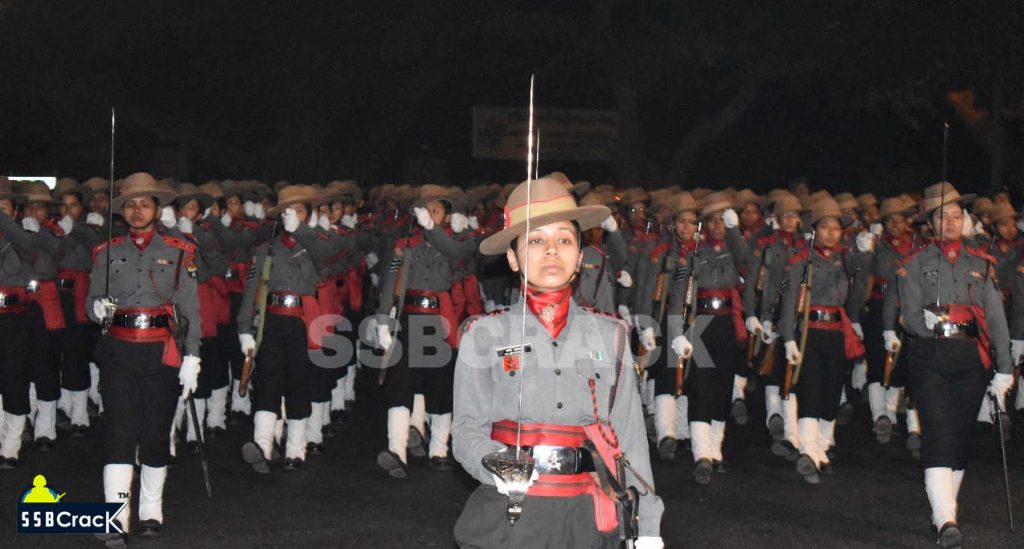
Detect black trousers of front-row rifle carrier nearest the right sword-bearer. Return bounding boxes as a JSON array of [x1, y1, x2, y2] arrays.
[[782, 328, 851, 421]]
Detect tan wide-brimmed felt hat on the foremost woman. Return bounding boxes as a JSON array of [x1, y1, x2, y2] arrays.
[[480, 177, 611, 255]]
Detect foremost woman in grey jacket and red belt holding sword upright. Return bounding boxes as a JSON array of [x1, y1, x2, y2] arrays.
[[452, 177, 664, 548]]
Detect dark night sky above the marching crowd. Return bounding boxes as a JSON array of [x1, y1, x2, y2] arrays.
[[0, 0, 1024, 197]]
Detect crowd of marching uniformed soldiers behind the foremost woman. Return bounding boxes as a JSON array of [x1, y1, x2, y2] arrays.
[[0, 172, 1024, 546]]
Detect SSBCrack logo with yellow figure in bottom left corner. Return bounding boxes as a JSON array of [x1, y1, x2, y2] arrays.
[[17, 474, 127, 534]]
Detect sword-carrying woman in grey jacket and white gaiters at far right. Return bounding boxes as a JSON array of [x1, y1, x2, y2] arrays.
[[896, 182, 1013, 547]]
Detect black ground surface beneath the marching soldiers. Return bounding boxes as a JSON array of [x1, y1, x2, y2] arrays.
[[0, 375, 1024, 549]]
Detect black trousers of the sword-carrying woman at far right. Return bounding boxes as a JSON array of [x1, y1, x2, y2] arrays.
[[907, 338, 990, 469]]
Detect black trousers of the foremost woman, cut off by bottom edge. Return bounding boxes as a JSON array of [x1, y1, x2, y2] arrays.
[[455, 484, 622, 549]]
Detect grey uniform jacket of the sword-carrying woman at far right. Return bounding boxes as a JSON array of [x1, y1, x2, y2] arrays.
[[897, 242, 1013, 374]]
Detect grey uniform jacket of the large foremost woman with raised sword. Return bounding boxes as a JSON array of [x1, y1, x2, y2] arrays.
[[452, 300, 665, 536]]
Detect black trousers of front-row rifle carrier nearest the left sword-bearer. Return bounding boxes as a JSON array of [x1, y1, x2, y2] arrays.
[[253, 314, 312, 419]]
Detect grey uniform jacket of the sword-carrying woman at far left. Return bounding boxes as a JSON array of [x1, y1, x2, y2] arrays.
[[85, 229, 201, 356]]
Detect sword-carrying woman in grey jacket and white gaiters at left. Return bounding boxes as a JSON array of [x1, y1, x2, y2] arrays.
[[86, 173, 201, 543]]
